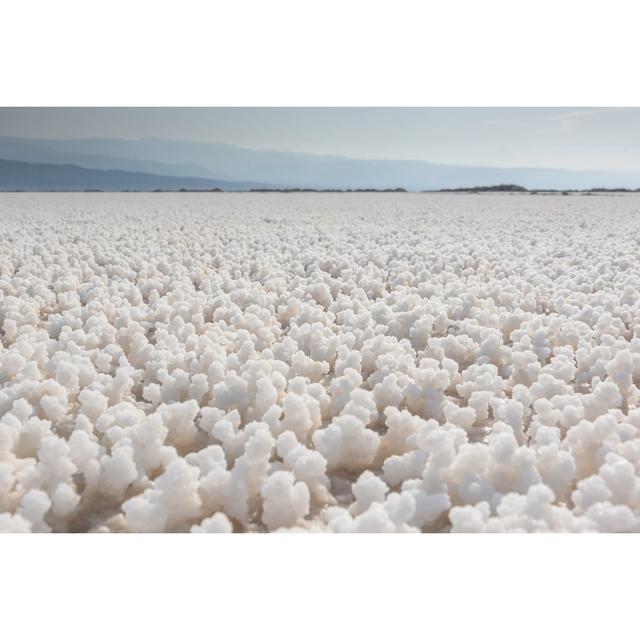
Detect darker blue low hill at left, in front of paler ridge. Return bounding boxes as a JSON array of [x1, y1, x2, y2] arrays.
[[0, 159, 266, 191]]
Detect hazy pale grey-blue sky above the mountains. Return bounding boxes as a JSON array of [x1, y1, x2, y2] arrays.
[[0, 107, 640, 171]]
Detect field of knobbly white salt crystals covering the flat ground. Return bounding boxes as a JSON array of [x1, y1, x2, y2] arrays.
[[0, 194, 640, 532]]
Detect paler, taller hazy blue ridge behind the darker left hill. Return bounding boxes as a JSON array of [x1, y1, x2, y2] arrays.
[[0, 137, 640, 191]]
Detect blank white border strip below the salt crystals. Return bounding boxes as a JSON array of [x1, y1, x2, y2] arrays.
[[0, 534, 640, 640]]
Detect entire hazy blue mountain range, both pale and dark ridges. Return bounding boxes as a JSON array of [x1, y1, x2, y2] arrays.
[[0, 137, 640, 191]]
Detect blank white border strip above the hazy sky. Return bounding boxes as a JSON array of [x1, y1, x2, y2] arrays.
[[0, 0, 640, 106]]
